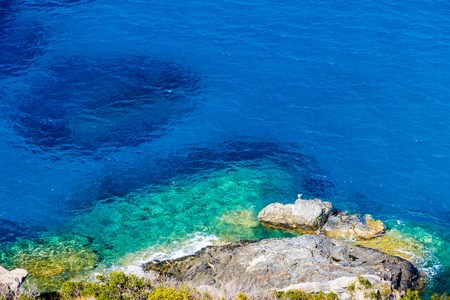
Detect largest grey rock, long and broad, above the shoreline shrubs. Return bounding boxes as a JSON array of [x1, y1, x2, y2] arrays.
[[144, 235, 419, 297]]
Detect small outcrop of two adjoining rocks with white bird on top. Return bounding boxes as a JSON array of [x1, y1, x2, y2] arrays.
[[258, 195, 385, 239]]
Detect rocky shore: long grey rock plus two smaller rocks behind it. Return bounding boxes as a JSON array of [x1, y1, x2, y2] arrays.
[[143, 195, 420, 299]]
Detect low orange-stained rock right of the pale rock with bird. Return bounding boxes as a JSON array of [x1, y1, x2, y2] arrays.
[[322, 213, 385, 239]]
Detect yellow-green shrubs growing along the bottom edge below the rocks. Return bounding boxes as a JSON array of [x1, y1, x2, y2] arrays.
[[0, 272, 449, 300]]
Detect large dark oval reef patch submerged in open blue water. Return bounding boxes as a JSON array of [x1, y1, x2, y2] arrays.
[[6, 56, 201, 154]]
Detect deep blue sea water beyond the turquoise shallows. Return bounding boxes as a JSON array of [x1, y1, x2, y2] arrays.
[[0, 0, 450, 292]]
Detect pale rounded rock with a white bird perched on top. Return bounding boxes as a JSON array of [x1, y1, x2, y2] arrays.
[[258, 195, 333, 231]]
